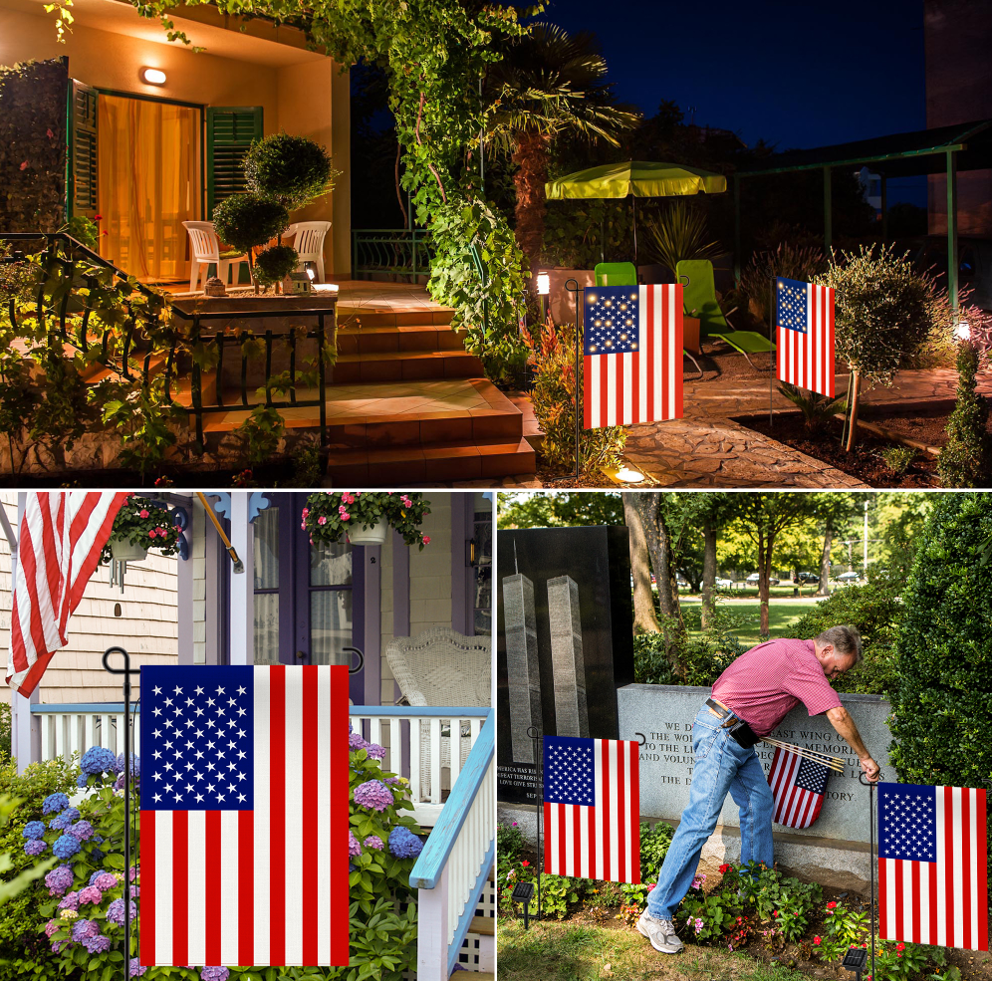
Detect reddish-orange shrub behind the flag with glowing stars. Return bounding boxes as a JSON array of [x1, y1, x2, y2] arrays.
[[523, 318, 627, 472]]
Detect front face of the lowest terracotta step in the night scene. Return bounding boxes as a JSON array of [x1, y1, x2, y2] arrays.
[[327, 437, 536, 487]]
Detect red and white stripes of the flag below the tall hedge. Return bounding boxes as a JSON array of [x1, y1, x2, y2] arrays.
[[878, 787, 989, 950]]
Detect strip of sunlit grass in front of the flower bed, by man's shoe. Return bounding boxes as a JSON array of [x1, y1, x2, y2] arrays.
[[497, 919, 806, 981]]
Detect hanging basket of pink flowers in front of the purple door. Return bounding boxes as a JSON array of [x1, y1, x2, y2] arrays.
[[303, 491, 431, 551]]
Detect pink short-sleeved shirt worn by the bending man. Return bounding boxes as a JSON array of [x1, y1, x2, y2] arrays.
[[713, 638, 840, 736]]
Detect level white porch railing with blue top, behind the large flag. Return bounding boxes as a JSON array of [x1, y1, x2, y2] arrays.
[[31, 702, 489, 825]]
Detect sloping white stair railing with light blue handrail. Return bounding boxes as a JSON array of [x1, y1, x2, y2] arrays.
[[410, 712, 496, 981]]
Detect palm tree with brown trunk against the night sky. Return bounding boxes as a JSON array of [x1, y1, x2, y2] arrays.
[[486, 23, 640, 273]]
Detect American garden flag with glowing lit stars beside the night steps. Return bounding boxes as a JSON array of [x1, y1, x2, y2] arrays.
[[583, 285, 682, 429]]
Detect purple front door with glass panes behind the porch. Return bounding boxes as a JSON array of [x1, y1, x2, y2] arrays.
[[254, 493, 365, 704]]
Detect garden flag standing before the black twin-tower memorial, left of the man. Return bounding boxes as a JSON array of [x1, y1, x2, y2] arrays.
[[544, 736, 641, 883]]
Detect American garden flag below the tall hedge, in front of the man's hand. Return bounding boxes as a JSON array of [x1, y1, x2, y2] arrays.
[[878, 783, 989, 950]]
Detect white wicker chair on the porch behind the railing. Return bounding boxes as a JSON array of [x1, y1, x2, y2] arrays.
[[386, 627, 492, 794]]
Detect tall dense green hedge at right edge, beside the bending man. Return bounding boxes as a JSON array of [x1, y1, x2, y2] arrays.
[[890, 493, 992, 900]]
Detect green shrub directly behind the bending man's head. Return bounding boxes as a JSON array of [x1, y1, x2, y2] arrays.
[[792, 575, 905, 695]]
